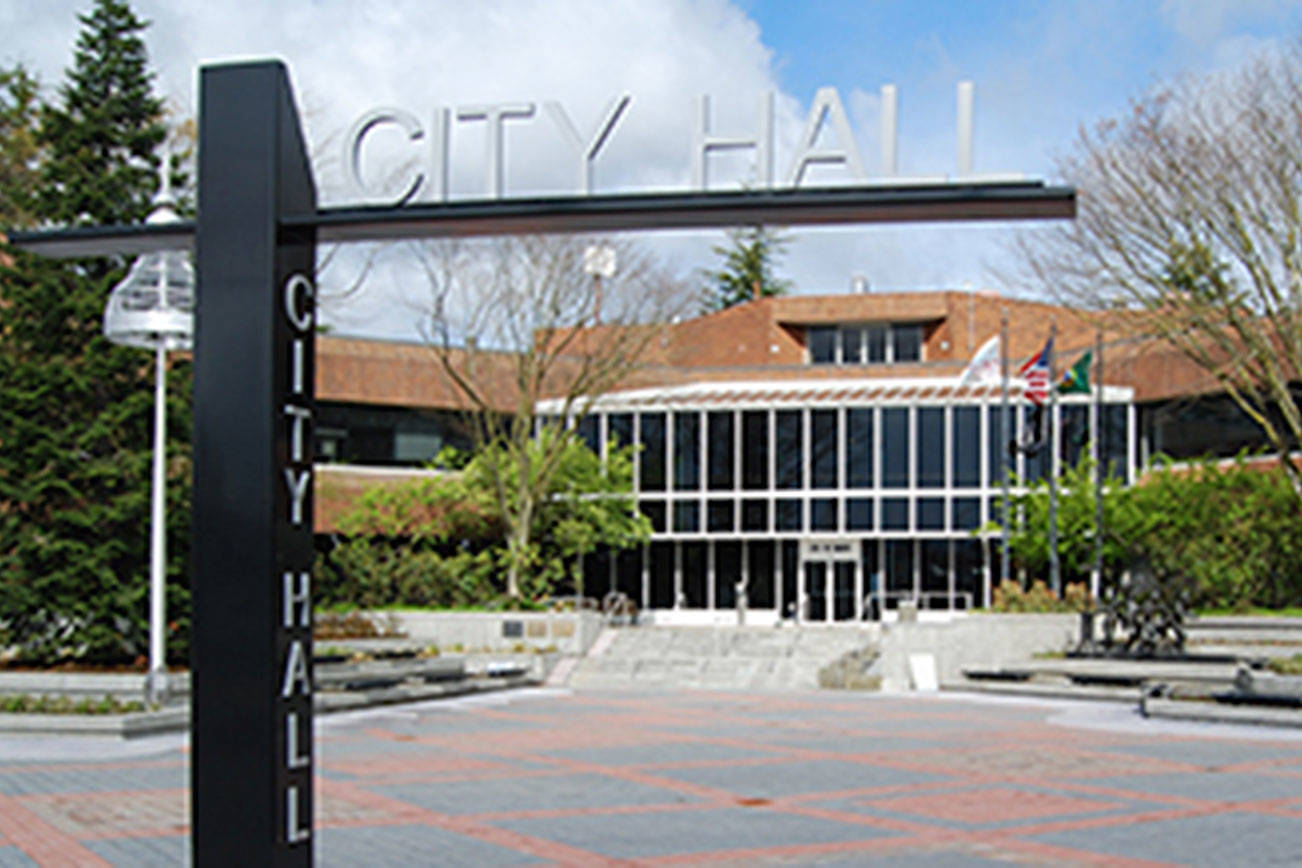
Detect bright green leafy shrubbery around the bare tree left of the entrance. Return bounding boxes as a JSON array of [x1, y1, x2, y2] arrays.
[[318, 437, 651, 608]]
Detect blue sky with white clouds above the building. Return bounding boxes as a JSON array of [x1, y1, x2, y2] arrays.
[[0, 0, 1302, 338]]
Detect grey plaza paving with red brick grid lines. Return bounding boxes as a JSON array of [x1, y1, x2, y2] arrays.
[[0, 690, 1302, 867]]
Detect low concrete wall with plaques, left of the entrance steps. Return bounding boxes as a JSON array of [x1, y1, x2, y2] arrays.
[[372, 612, 602, 655]]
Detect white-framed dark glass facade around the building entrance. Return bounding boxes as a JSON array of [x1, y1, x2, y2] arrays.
[[565, 398, 1135, 621]]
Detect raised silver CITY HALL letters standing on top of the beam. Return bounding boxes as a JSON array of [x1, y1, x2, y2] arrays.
[[342, 82, 973, 206]]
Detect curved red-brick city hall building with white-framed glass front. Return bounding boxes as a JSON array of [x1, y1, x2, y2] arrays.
[[316, 292, 1260, 623]]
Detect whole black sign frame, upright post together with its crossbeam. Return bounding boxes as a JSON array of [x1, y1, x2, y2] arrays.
[[13, 62, 1075, 868]]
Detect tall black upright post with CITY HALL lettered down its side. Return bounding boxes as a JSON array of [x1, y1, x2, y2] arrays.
[[190, 62, 316, 868]]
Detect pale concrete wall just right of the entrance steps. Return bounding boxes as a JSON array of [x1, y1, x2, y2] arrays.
[[879, 613, 1081, 691]]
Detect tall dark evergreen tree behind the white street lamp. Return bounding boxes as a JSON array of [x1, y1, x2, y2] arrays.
[[0, 0, 190, 661]]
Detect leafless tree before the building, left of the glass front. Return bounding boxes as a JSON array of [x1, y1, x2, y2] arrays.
[[415, 236, 693, 597]]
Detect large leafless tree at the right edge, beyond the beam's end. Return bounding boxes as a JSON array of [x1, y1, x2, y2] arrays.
[[1017, 43, 1302, 498]]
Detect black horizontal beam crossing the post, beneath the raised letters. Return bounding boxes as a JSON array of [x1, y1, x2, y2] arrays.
[[5, 181, 1075, 258]]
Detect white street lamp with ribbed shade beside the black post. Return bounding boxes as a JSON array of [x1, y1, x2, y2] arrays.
[[104, 171, 194, 705]]
